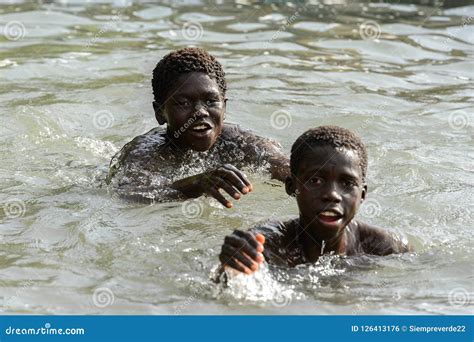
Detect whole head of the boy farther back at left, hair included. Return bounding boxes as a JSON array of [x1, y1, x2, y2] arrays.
[[152, 48, 227, 151]]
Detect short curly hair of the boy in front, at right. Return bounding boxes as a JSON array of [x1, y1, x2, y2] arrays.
[[290, 126, 367, 181]]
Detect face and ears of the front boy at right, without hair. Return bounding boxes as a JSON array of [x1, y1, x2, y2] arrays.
[[287, 146, 367, 238]]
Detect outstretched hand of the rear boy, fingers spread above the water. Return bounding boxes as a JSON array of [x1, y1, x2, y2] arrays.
[[197, 164, 252, 208]]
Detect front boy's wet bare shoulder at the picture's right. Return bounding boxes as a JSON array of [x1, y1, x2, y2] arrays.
[[356, 221, 413, 255]]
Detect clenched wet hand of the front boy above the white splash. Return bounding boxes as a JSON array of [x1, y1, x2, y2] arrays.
[[219, 230, 265, 274]]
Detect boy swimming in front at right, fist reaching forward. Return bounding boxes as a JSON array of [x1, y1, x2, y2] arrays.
[[219, 126, 411, 274]]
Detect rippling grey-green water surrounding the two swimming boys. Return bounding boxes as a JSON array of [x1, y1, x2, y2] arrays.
[[0, 0, 474, 314]]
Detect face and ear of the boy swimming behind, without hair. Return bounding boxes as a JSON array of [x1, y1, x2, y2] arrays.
[[154, 72, 225, 151]]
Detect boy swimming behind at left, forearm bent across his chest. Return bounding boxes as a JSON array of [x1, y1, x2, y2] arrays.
[[107, 48, 289, 208]]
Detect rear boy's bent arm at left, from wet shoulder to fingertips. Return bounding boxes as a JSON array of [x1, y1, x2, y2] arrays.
[[106, 132, 252, 208]]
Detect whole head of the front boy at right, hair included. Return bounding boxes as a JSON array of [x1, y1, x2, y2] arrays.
[[286, 126, 367, 234]]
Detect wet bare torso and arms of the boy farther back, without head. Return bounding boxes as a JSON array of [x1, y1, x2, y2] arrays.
[[107, 123, 289, 207]]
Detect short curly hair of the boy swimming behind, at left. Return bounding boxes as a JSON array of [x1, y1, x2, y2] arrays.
[[151, 47, 227, 107]]
